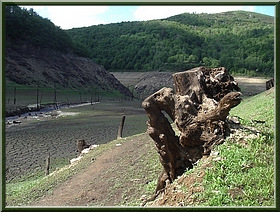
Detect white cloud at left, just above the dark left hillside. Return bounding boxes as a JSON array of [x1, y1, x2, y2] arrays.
[[22, 5, 109, 29]]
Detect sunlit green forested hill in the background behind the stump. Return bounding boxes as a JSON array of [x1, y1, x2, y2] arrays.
[[66, 11, 274, 76]]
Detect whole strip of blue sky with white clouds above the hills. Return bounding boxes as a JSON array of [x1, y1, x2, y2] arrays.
[[23, 5, 275, 29]]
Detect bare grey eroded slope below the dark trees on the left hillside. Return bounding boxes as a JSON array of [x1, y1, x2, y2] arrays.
[[5, 45, 132, 96]]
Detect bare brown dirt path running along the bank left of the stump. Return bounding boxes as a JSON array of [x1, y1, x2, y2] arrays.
[[32, 135, 156, 206]]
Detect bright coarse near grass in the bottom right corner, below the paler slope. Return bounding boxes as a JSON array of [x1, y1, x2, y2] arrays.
[[201, 135, 274, 206]]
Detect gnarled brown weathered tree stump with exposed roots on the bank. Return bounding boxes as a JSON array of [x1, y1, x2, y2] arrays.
[[142, 67, 241, 193]]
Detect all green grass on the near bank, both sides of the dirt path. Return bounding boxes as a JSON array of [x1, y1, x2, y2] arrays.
[[7, 90, 275, 206]]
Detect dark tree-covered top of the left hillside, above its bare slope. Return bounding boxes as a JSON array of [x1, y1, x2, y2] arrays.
[[5, 5, 88, 56]]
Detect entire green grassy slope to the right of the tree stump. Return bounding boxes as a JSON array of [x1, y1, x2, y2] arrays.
[[199, 89, 275, 206]]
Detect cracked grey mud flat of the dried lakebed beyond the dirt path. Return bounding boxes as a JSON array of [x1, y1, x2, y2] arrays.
[[5, 102, 147, 182]]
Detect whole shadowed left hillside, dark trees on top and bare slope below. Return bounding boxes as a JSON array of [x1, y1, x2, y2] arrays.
[[5, 5, 131, 96]]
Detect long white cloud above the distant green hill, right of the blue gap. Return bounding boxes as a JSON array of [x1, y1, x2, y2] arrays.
[[133, 5, 254, 21]]
